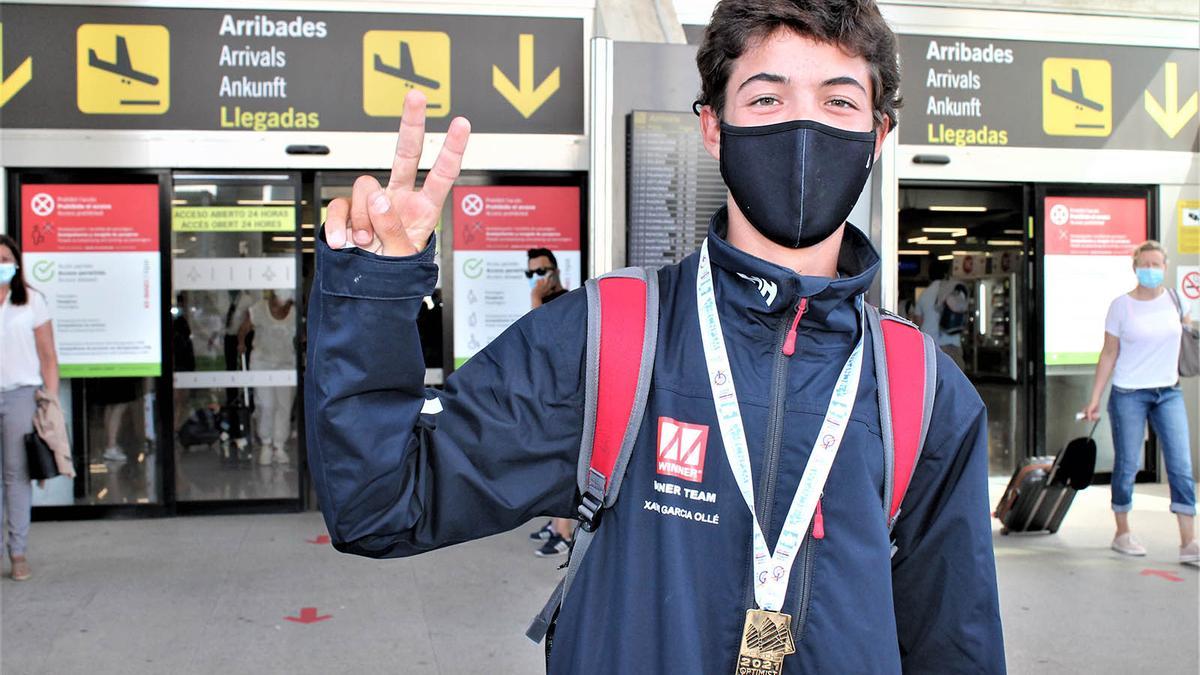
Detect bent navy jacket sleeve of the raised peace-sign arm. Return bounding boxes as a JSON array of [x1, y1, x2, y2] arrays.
[[305, 230, 587, 557]]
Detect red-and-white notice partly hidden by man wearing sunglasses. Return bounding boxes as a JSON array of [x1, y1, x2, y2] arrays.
[[452, 186, 582, 368]]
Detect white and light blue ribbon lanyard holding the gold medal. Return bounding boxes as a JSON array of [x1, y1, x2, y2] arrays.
[[696, 239, 865, 611]]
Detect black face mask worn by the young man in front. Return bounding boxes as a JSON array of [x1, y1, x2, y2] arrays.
[[721, 120, 875, 249]]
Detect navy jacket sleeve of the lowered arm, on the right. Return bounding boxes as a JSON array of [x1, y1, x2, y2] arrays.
[[892, 353, 1004, 674]]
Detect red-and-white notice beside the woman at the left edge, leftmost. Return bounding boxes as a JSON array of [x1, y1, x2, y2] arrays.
[[22, 185, 162, 377]]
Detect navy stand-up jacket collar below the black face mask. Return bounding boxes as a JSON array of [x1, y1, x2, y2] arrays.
[[708, 207, 880, 333]]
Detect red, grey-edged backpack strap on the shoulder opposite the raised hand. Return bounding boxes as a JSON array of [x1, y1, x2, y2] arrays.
[[866, 305, 937, 535]]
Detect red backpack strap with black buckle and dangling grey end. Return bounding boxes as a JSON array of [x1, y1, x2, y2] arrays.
[[526, 268, 659, 643]]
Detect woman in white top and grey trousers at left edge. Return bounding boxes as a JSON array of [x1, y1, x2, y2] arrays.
[[0, 234, 59, 581]]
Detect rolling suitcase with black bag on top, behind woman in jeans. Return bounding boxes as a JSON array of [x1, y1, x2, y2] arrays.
[[995, 422, 1099, 534]]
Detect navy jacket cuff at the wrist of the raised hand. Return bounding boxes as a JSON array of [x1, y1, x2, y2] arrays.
[[316, 227, 438, 300]]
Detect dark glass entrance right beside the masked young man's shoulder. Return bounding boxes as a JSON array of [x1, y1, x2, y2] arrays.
[[898, 185, 1027, 476]]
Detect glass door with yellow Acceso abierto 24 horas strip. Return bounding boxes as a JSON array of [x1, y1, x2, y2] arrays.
[[172, 174, 300, 501]]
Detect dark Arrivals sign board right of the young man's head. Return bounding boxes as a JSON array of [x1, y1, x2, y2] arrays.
[[899, 35, 1200, 153]]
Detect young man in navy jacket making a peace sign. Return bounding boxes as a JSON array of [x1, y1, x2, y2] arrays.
[[306, 0, 1004, 674]]
